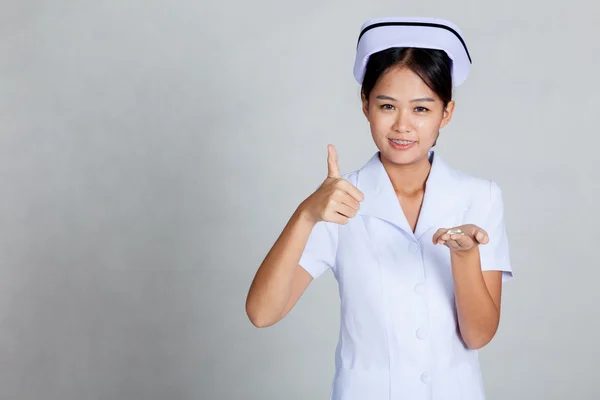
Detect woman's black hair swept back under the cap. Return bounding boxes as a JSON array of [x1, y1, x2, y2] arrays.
[[361, 47, 452, 146]]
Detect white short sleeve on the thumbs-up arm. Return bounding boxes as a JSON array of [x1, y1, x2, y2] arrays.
[[300, 221, 339, 278]]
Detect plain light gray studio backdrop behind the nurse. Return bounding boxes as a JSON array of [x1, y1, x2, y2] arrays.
[[0, 0, 600, 400]]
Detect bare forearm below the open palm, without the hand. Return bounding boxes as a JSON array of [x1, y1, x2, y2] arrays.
[[451, 247, 500, 349]]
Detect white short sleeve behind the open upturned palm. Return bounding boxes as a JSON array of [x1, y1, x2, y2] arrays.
[[479, 181, 513, 282]]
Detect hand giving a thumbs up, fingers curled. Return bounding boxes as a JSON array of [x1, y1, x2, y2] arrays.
[[301, 144, 364, 225]]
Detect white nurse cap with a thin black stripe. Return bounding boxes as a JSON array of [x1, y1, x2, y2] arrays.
[[354, 17, 471, 87]]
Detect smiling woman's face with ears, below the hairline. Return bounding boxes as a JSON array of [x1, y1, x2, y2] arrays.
[[363, 67, 454, 165]]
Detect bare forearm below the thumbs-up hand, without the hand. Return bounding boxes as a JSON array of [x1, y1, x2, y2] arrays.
[[246, 207, 314, 326]]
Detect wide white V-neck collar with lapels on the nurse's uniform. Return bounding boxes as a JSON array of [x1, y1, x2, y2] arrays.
[[356, 150, 467, 238]]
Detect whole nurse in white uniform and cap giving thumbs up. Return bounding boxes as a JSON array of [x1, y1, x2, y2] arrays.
[[246, 18, 512, 400]]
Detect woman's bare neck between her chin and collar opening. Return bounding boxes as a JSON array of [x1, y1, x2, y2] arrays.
[[380, 153, 431, 196]]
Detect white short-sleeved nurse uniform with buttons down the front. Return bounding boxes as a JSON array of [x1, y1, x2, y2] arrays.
[[300, 151, 512, 400]]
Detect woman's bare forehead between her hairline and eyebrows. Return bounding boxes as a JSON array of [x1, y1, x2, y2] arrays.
[[373, 66, 437, 99]]
